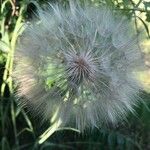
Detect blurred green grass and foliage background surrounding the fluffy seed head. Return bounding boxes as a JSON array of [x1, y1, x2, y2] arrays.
[[0, 0, 150, 150]]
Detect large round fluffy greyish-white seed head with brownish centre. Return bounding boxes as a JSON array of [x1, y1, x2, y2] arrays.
[[14, 4, 142, 131]]
